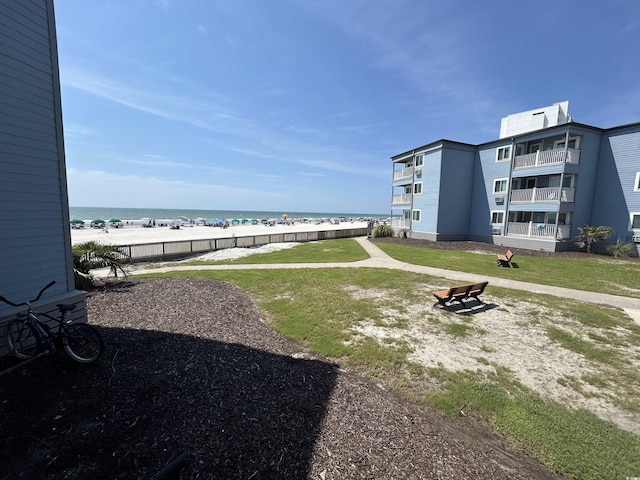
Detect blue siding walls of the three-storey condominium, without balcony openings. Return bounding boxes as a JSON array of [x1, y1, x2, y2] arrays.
[[392, 109, 640, 252]]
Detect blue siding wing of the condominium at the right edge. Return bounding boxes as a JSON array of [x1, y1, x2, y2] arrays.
[[592, 125, 640, 242]]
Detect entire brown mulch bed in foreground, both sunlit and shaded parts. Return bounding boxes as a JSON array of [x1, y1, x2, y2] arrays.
[[0, 278, 558, 480]]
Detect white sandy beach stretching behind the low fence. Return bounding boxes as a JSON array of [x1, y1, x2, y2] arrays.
[[71, 221, 367, 245]]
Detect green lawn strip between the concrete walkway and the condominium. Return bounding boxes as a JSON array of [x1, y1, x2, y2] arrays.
[[376, 242, 640, 298]]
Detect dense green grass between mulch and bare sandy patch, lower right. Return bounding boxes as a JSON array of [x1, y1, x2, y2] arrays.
[[424, 369, 640, 480]]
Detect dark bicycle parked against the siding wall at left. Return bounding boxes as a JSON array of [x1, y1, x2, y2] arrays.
[[0, 280, 104, 363]]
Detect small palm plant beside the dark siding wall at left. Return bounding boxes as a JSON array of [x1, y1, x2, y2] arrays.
[[71, 241, 127, 290]]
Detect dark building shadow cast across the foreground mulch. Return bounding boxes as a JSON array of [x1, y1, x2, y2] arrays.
[[0, 327, 337, 480]]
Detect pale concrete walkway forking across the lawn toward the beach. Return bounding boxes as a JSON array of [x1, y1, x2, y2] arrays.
[[131, 237, 640, 323]]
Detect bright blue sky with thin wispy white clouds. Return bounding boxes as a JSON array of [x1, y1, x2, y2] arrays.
[[55, 0, 640, 213]]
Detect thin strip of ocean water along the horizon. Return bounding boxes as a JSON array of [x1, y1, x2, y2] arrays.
[[69, 207, 389, 221]]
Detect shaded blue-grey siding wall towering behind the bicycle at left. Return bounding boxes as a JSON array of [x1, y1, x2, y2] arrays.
[[0, 0, 82, 330]]
